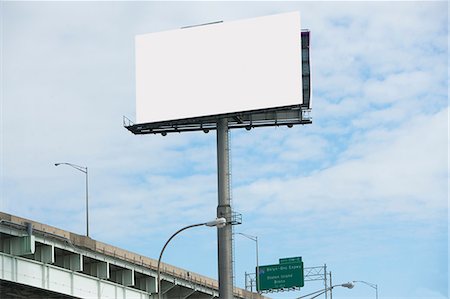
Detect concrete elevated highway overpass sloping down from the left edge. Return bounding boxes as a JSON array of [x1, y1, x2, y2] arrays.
[[0, 212, 265, 299]]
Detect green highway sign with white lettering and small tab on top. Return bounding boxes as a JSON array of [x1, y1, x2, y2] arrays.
[[256, 258, 305, 291]]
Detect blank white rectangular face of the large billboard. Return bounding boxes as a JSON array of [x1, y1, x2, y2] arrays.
[[136, 12, 302, 123]]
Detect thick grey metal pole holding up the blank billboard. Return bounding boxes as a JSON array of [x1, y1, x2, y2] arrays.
[[217, 118, 233, 299]]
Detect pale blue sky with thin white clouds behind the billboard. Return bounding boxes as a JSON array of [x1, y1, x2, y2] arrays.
[[0, 1, 449, 299]]
